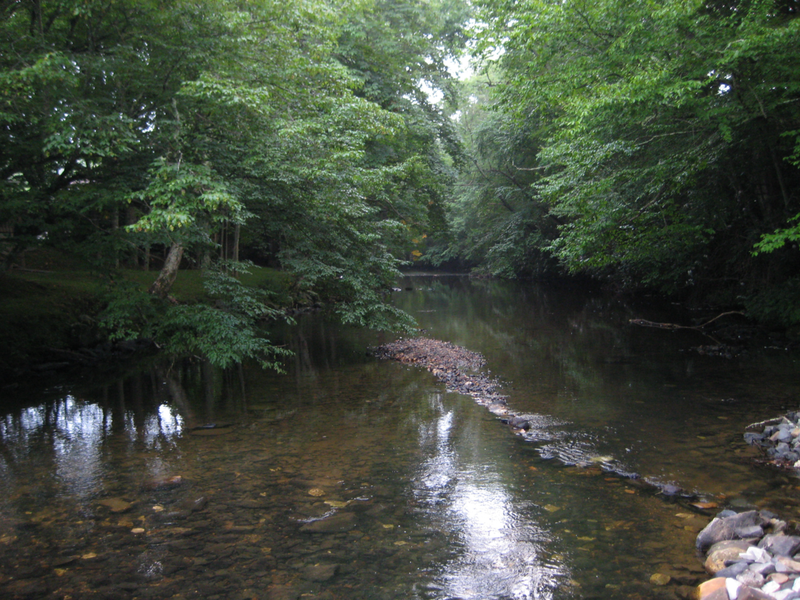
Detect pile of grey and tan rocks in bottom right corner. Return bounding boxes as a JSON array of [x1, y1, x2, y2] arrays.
[[696, 510, 800, 600]]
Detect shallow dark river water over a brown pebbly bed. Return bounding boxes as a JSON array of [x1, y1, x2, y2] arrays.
[[0, 277, 800, 600]]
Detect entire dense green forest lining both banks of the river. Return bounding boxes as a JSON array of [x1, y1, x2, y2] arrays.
[[0, 0, 800, 365]]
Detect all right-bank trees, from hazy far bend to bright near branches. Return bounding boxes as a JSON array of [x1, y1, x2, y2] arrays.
[[428, 0, 800, 325]]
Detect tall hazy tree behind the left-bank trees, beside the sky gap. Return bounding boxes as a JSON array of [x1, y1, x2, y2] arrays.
[[336, 0, 470, 259]]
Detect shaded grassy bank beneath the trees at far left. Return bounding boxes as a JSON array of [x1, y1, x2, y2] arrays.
[[0, 267, 292, 375]]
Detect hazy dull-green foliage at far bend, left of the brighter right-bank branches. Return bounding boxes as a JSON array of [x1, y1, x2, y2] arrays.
[[432, 75, 556, 278]]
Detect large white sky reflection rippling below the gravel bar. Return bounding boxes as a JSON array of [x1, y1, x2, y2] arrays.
[[414, 398, 566, 599]]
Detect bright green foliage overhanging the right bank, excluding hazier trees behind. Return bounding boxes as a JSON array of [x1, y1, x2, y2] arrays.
[[462, 0, 800, 318]]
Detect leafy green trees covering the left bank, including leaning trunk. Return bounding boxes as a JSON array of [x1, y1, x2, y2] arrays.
[[0, 0, 476, 363]]
